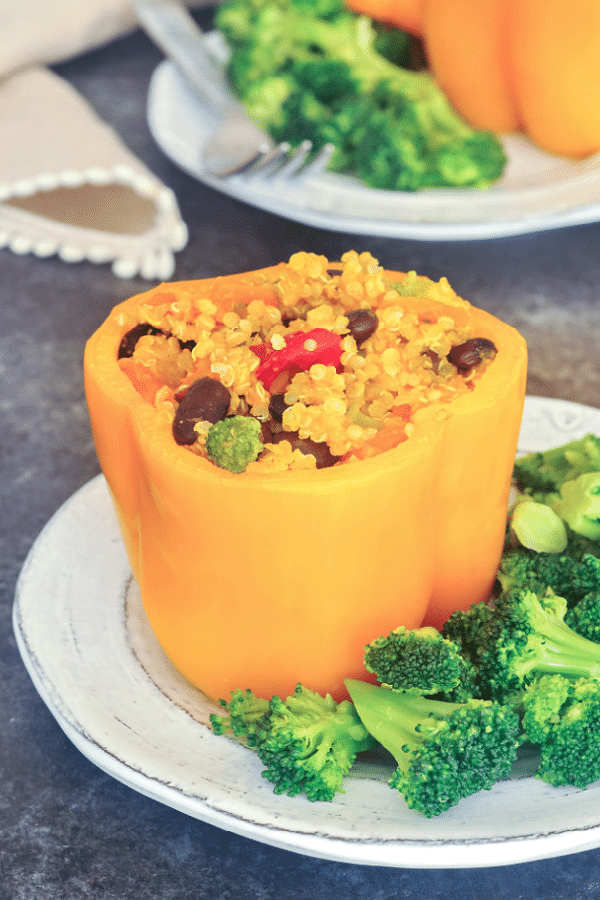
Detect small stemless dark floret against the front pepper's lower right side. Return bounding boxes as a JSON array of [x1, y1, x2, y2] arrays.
[[364, 626, 472, 695]]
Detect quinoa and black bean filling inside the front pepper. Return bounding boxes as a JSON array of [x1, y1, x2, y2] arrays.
[[118, 251, 497, 472]]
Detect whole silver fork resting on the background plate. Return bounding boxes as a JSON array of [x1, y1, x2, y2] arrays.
[[133, 0, 333, 178]]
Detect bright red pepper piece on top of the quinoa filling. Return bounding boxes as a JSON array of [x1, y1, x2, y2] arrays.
[[250, 328, 342, 390]]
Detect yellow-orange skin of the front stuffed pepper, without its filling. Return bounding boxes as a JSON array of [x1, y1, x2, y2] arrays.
[[85, 273, 527, 699]]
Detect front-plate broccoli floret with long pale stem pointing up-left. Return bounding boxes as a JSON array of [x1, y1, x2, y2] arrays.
[[346, 679, 520, 817]]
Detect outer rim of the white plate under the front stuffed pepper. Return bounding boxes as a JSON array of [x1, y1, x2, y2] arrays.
[[13, 397, 600, 868]]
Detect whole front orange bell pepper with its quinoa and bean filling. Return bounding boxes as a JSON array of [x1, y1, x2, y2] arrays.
[[85, 252, 526, 698]]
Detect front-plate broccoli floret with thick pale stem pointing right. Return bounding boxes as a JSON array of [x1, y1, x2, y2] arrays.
[[444, 589, 600, 703]]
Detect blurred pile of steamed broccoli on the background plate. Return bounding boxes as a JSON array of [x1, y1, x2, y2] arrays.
[[215, 0, 506, 191]]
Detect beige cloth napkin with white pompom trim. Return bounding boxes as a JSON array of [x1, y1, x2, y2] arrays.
[[0, 0, 204, 280]]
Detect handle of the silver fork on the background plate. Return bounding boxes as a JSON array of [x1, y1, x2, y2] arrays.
[[133, 0, 238, 115]]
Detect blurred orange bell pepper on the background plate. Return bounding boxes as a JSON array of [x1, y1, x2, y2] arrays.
[[347, 0, 600, 158]]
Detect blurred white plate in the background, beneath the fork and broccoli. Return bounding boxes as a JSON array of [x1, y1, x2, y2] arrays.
[[147, 42, 600, 240]]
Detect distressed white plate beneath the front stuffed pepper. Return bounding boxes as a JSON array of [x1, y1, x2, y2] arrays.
[[14, 397, 600, 868]]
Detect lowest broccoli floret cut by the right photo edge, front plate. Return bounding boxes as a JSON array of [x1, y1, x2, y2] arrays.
[[522, 675, 600, 789]]
